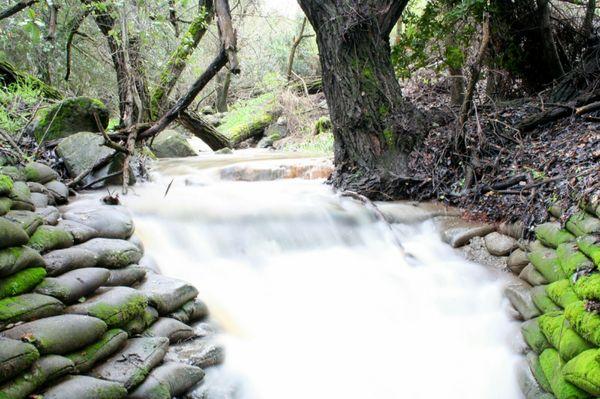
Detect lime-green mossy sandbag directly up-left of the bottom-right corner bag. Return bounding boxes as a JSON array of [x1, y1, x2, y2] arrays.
[[539, 312, 592, 361]]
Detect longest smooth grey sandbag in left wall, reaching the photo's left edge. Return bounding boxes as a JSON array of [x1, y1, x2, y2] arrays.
[[1, 314, 106, 355]]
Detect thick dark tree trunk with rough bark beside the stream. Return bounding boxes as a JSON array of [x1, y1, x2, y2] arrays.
[[299, 0, 426, 198]]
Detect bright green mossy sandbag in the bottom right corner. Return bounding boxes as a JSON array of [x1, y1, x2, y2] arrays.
[[563, 349, 600, 396]]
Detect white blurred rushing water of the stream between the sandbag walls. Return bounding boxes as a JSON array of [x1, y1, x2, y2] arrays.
[[124, 151, 521, 399]]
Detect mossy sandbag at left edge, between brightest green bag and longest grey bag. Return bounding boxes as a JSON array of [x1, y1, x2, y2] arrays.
[[0, 294, 65, 329]]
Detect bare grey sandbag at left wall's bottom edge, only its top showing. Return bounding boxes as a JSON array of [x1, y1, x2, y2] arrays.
[[42, 375, 127, 399]]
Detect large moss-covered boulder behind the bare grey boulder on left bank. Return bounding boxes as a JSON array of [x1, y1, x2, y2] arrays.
[[27, 97, 109, 143]]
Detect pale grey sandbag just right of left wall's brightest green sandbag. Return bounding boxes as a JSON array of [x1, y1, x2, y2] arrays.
[[35, 268, 110, 304]]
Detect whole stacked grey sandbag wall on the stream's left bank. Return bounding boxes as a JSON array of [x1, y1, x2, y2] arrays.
[[0, 163, 223, 399]]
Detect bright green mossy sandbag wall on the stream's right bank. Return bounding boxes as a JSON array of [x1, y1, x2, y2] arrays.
[[506, 206, 600, 399]]
